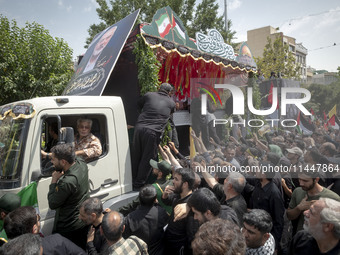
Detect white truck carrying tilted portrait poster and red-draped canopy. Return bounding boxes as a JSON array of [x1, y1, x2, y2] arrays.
[[0, 7, 256, 234]]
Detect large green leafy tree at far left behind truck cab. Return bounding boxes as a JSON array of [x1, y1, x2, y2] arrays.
[[0, 15, 73, 105]]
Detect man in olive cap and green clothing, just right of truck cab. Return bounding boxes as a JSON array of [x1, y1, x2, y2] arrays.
[[150, 159, 172, 214]]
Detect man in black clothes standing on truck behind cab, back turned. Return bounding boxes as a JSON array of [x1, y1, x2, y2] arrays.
[[132, 83, 175, 190]]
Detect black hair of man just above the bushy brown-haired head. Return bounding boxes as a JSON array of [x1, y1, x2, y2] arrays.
[[188, 188, 221, 216]]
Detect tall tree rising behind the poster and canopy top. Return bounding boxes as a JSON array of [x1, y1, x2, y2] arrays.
[[85, 0, 236, 48]]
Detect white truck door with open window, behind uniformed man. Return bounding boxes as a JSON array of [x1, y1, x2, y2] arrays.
[[32, 108, 122, 234]]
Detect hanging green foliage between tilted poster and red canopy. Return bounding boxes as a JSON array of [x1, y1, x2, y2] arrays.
[[133, 35, 161, 95]]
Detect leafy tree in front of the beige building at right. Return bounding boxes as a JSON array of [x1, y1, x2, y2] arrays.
[[255, 36, 300, 79]]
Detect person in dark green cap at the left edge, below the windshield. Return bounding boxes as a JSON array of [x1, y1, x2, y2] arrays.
[[0, 193, 21, 244]]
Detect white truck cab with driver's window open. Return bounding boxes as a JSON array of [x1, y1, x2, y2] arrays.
[[0, 96, 138, 234]]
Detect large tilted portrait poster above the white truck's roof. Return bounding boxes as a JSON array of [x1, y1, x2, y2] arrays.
[[63, 10, 139, 96]]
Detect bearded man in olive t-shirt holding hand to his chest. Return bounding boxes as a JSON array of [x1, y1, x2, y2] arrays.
[[287, 164, 340, 234]]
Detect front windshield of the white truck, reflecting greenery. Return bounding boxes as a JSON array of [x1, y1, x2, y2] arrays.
[[0, 116, 30, 189]]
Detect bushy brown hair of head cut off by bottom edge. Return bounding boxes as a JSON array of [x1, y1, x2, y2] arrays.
[[192, 219, 246, 255]]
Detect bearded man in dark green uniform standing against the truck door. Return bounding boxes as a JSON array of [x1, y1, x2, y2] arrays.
[[48, 144, 89, 249]]
